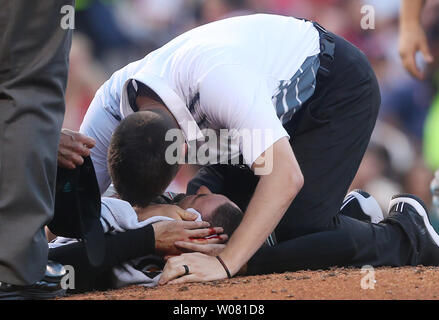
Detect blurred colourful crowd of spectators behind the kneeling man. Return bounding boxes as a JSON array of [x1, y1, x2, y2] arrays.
[[64, 0, 439, 220]]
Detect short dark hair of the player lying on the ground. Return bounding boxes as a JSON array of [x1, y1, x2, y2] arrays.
[[206, 202, 243, 237]]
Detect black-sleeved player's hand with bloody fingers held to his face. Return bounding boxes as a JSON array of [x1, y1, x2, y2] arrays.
[[152, 221, 224, 256]]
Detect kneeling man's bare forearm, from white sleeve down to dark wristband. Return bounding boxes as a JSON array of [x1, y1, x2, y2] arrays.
[[221, 139, 303, 273]]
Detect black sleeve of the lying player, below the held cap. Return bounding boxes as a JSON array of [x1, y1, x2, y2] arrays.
[[49, 225, 155, 293]]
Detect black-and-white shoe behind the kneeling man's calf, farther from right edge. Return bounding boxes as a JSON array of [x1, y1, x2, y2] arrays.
[[340, 190, 384, 223]]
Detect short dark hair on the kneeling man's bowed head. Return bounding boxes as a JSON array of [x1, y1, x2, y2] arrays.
[[108, 110, 182, 207]]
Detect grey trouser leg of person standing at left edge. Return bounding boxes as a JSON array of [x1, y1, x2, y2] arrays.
[[0, 0, 74, 285]]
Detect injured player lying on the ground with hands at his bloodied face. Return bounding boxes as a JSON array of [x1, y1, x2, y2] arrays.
[[49, 188, 242, 292]]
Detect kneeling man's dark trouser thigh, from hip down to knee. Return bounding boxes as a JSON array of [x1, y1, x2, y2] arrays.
[[276, 35, 380, 241]]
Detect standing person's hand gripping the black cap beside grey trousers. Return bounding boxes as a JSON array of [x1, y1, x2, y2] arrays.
[[58, 129, 95, 169]]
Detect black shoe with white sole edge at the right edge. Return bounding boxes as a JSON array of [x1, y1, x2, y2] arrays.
[[386, 194, 439, 266]]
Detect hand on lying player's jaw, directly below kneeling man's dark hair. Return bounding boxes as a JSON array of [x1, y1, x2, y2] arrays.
[[133, 204, 197, 221]]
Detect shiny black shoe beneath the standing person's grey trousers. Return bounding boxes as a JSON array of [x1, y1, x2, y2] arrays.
[[0, 261, 66, 300]]
